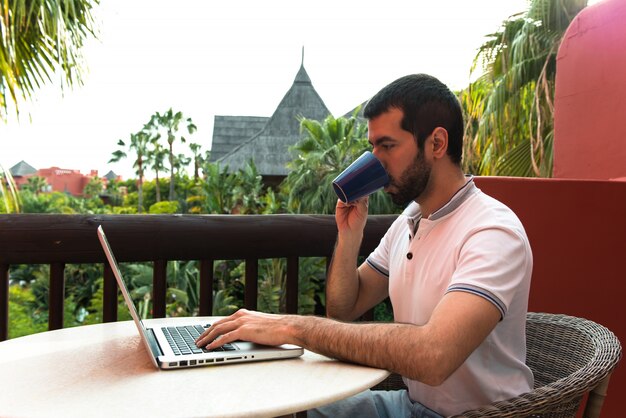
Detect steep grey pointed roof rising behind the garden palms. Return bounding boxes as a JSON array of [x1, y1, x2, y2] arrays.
[[218, 64, 331, 176]]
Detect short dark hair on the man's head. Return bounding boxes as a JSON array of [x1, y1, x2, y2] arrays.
[[363, 74, 463, 165]]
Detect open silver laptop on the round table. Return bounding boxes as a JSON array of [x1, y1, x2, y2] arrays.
[[98, 225, 304, 369]]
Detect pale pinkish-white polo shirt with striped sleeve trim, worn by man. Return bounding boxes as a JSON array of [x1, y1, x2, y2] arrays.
[[367, 178, 533, 415]]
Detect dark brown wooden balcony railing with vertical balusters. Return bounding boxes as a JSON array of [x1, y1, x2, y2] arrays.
[[0, 214, 396, 341]]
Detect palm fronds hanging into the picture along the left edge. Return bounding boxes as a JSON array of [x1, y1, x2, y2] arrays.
[[0, 0, 99, 213]]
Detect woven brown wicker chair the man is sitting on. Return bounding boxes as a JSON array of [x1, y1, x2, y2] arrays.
[[374, 313, 622, 418]]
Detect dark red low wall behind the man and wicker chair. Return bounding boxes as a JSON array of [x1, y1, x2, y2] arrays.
[[476, 177, 626, 417]]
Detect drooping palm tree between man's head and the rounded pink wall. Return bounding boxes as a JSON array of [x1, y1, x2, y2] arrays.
[[461, 0, 587, 177]]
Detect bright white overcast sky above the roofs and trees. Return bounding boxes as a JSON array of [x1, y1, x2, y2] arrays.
[[0, 0, 527, 178]]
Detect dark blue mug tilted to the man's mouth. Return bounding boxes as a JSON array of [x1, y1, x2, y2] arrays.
[[333, 151, 389, 203]]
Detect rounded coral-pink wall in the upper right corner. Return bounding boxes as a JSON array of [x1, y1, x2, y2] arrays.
[[553, 0, 626, 180]]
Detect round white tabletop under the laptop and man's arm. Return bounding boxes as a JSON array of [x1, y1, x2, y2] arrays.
[[0, 318, 389, 417]]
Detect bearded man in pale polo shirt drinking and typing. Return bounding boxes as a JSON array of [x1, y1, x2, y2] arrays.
[[198, 74, 533, 417]]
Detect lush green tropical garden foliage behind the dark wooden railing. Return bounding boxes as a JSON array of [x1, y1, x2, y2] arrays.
[[10, 110, 386, 335]]
